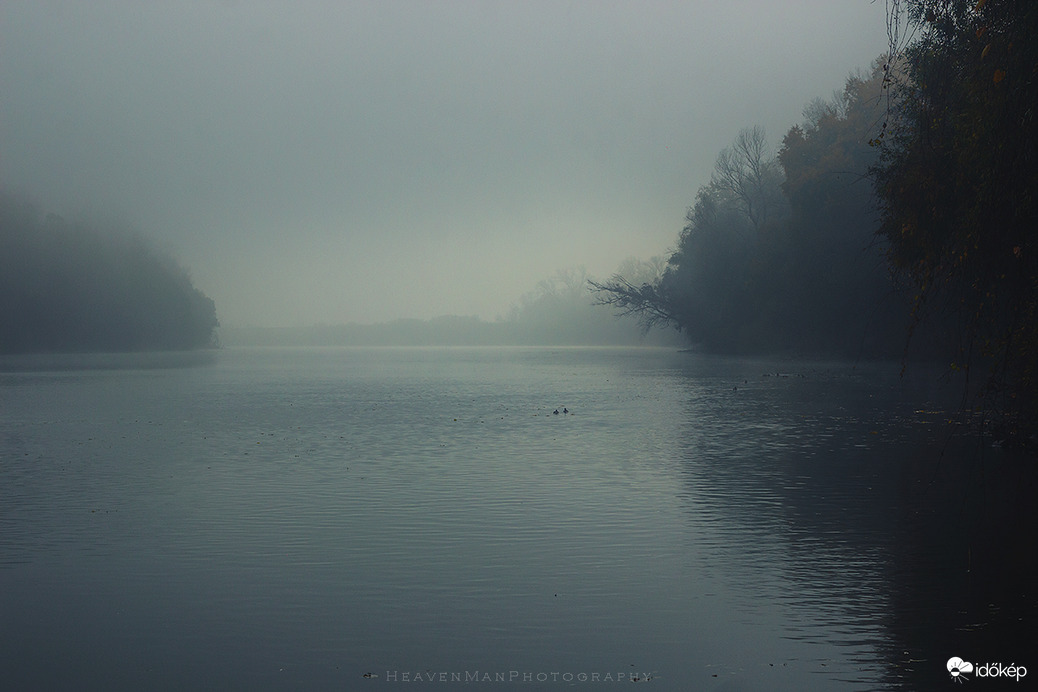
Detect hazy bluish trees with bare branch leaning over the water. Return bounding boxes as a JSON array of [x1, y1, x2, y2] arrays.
[[594, 63, 907, 356]]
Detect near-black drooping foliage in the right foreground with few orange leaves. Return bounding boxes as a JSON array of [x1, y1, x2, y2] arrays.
[[875, 0, 1038, 435]]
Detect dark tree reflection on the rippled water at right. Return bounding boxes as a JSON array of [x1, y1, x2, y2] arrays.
[[668, 356, 1036, 690]]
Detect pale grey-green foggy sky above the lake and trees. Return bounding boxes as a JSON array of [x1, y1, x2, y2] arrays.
[[0, 0, 886, 326]]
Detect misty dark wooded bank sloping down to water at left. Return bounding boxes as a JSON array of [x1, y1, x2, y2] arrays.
[[0, 193, 218, 353]]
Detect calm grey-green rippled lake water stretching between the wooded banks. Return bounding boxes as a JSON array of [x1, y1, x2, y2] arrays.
[[0, 349, 1038, 691]]
